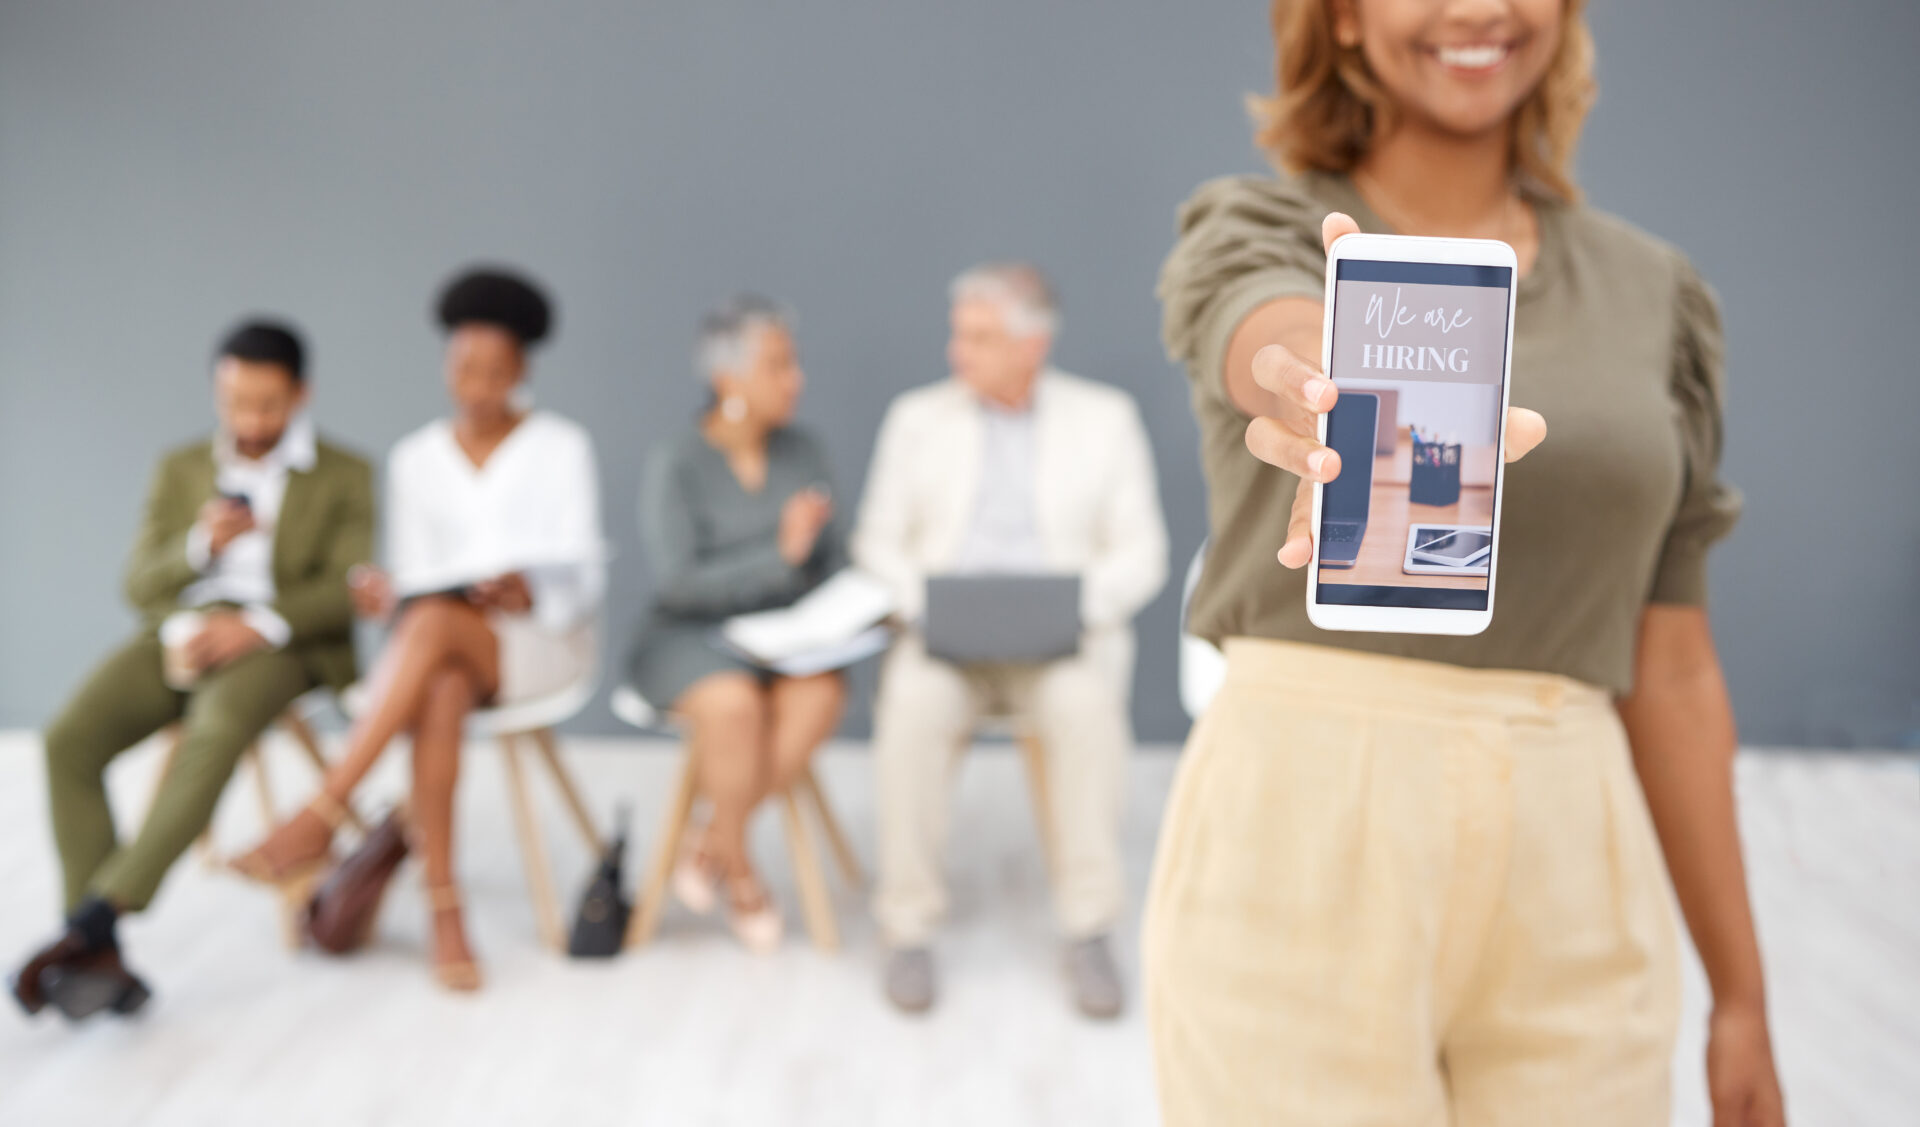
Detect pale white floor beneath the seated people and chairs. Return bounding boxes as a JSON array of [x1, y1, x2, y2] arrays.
[[0, 733, 1920, 1127]]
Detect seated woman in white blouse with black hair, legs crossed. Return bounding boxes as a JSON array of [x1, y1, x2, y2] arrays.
[[234, 271, 605, 991]]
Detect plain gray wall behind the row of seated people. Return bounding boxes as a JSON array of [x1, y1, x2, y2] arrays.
[[0, 0, 1920, 745]]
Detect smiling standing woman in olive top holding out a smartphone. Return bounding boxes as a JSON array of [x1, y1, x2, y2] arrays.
[[1144, 0, 1782, 1127]]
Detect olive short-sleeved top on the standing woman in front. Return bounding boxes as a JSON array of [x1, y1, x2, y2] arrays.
[[1160, 173, 1740, 693]]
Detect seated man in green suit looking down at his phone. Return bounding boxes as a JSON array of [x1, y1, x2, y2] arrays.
[[12, 321, 372, 1019]]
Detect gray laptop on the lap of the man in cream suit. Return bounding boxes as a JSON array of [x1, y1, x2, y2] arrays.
[[927, 574, 1081, 664]]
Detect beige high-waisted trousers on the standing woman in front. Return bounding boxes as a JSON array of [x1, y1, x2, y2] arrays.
[[1144, 639, 1680, 1127]]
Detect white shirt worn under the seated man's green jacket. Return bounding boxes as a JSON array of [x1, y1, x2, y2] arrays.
[[180, 411, 315, 649]]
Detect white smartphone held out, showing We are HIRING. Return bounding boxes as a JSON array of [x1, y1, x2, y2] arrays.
[[1308, 234, 1519, 634]]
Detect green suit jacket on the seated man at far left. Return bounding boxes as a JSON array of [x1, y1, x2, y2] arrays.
[[127, 440, 372, 691]]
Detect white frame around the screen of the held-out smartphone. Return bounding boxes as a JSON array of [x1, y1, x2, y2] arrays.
[[1308, 234, 1521, 634]]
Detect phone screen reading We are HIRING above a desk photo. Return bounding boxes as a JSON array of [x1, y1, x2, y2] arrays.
[[1315, 259, 1513, 611]]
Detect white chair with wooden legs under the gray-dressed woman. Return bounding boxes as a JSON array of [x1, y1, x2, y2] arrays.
[[612, 687, 866, 950]]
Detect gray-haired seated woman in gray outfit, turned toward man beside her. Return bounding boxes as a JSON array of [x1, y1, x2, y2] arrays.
[[628, 298, 847, 952]]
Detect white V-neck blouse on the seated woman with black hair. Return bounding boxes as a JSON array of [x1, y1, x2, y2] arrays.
[[386, 411, 607, 632]]
